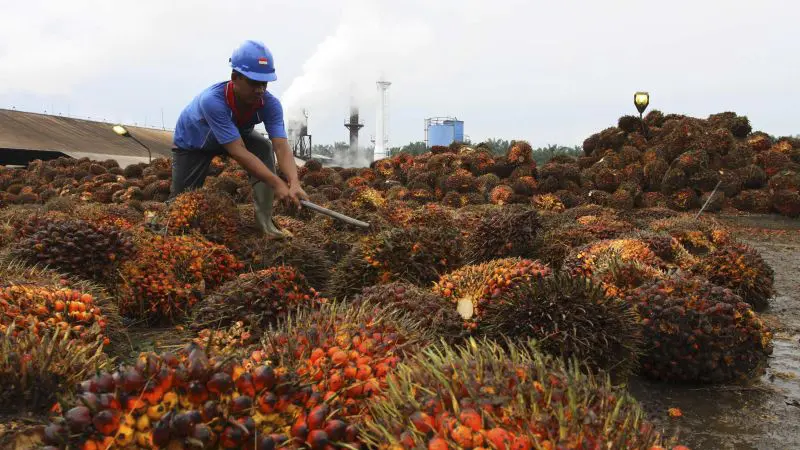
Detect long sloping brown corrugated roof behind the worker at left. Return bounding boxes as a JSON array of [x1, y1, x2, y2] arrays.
[[0, 109, 172, 160]]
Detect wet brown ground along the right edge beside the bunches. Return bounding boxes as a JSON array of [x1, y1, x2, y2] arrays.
[[630, 216, 800, 450]]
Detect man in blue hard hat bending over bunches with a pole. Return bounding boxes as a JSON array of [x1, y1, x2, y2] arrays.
[[170, 40, 308, 237]]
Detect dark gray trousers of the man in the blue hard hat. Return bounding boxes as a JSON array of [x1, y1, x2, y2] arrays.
[[168, 130, 275, 201]]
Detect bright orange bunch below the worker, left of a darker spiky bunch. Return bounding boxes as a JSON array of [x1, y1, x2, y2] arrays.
[[116, 233, 243, 321]]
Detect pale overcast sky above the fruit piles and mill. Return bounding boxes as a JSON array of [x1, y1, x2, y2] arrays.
[[0, 0, 800, 146]]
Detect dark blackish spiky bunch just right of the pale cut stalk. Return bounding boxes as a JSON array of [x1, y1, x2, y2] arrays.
[[479, 272, 642, 378]]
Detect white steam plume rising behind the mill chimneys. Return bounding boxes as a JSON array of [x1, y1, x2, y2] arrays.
[[281, 0, 432, 166]]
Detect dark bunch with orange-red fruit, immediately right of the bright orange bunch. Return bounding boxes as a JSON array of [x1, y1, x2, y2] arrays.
[[191, 266, 324, 330]]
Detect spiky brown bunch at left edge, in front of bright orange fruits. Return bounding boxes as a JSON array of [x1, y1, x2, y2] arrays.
[[0, 324, 111, 414]]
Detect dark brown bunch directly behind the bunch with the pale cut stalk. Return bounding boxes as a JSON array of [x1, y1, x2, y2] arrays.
[[464, 205, 542, 263]]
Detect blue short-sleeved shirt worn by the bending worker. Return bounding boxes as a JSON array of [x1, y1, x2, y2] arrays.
[[173, 81, 287, 150]]
